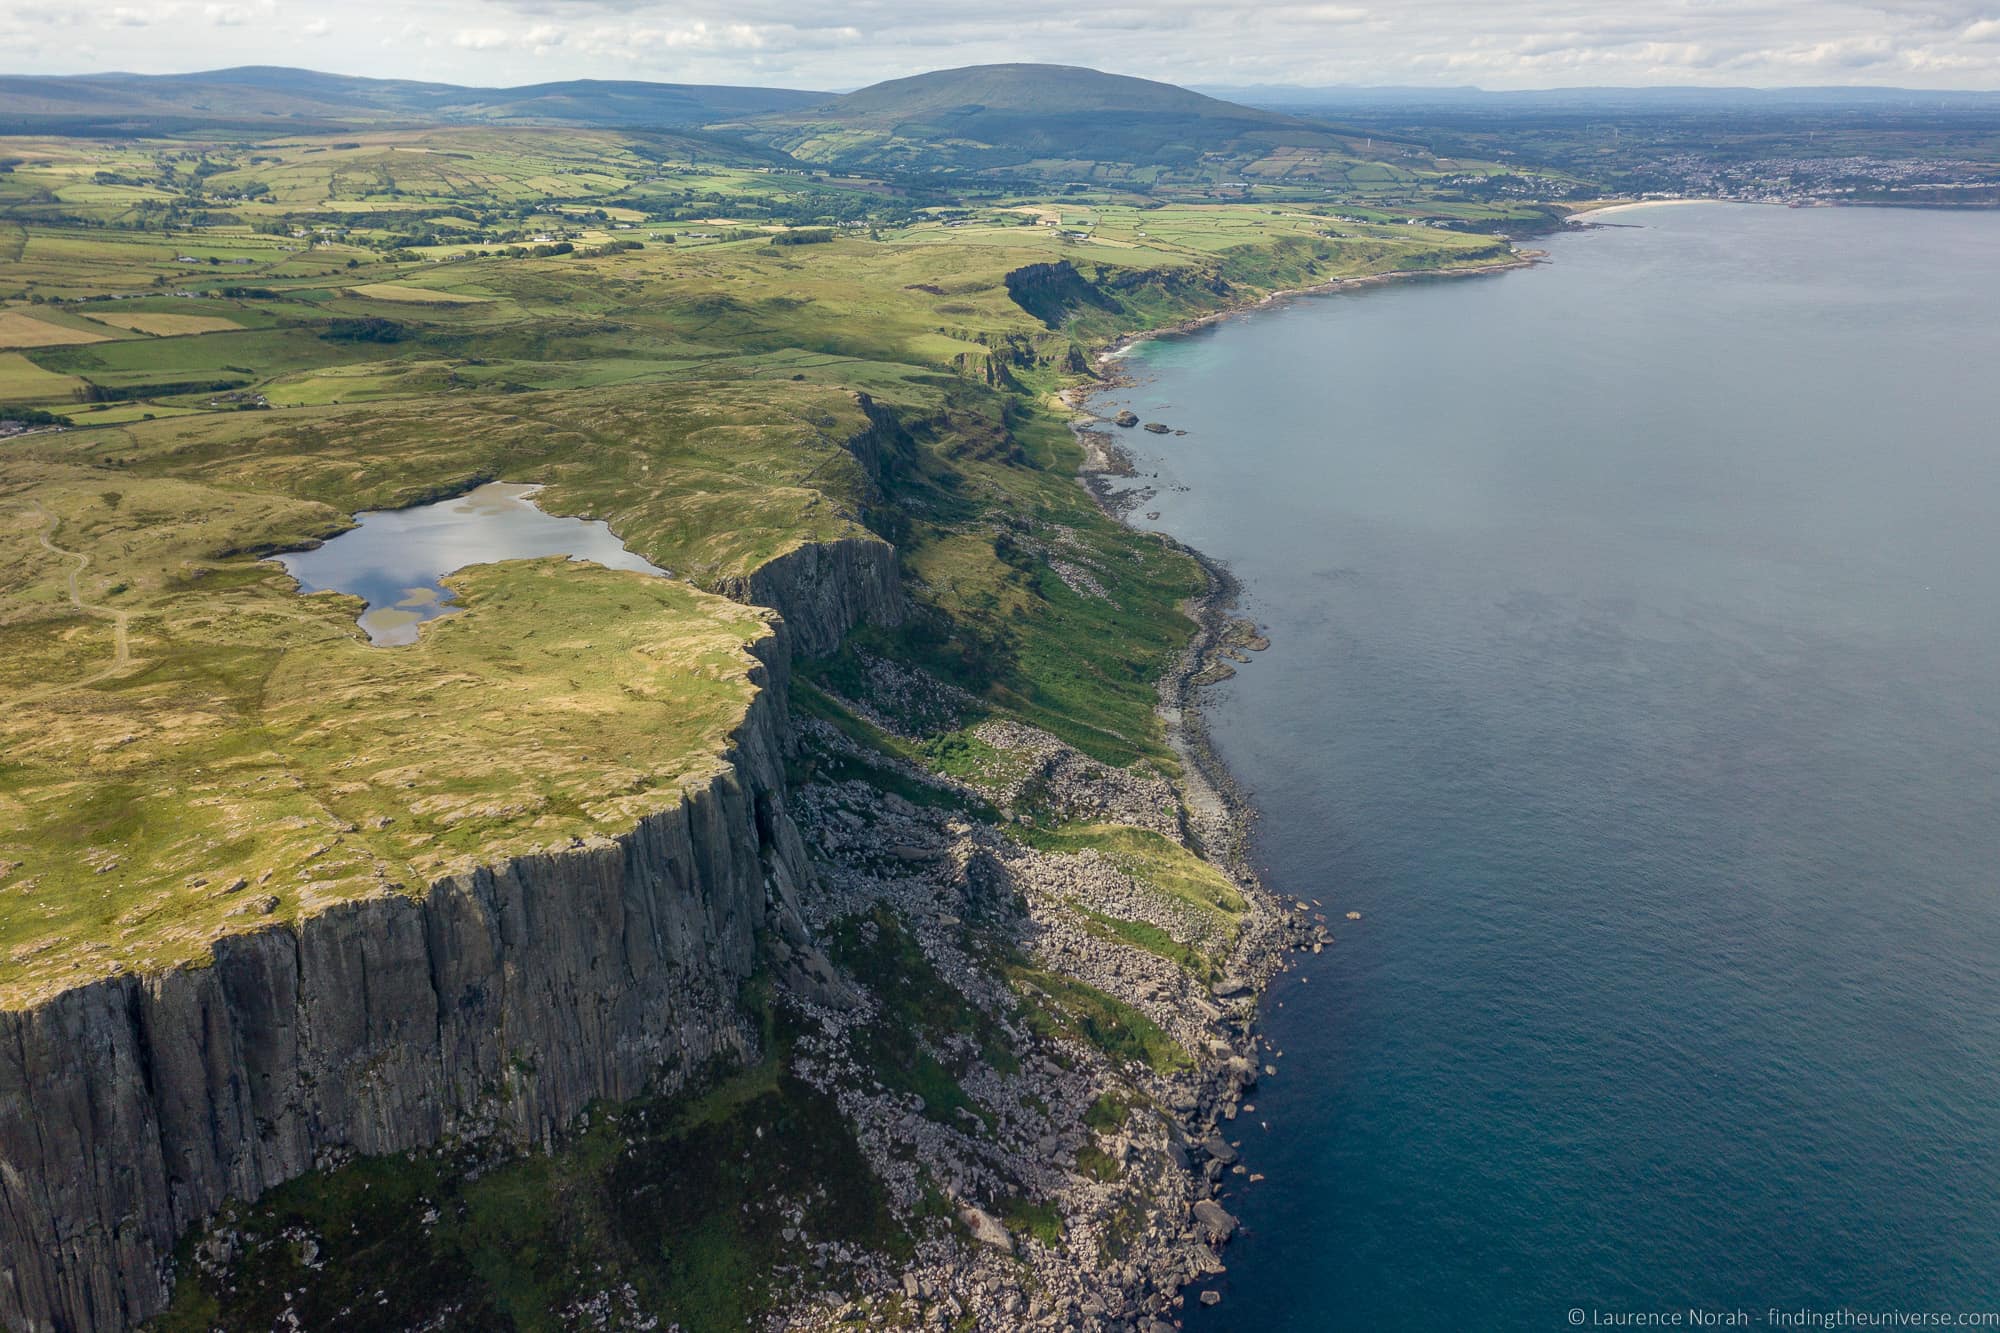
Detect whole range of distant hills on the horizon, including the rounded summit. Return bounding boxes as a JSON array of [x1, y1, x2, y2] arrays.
[[0, 64, 1438, 192]]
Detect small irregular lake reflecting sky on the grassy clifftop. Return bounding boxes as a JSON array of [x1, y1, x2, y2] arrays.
[[276, 482, 666, 646]]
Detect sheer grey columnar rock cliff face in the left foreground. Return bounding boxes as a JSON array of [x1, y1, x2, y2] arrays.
[[0, 624, 836, 1333]]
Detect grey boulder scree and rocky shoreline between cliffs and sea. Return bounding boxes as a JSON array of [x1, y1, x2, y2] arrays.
[[752, 250, 1542, 1333]]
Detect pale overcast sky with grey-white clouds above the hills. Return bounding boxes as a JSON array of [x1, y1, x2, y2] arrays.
[[11, 0, 2000, 90]]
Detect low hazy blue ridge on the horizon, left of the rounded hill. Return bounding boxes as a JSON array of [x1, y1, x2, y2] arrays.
[[0, 66, 826, 130]]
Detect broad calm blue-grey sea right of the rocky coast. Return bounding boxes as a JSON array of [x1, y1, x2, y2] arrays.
[[1108, 206, 2000, 1333]]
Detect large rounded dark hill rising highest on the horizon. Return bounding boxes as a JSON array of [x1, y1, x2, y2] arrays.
[[732, 64, 1400, 178]]
